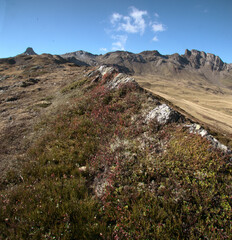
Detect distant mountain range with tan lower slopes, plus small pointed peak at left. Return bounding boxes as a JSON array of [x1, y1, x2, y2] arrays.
[[12, 47, 232, 89]]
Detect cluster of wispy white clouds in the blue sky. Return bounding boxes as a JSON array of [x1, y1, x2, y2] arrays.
[[107, 7, 167, 50]]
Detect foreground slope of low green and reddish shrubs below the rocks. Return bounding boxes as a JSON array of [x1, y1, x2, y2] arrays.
[[0, 68, 232, 239]]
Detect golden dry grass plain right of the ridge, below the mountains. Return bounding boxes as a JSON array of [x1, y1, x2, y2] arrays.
[[135, 75, 232, 138]]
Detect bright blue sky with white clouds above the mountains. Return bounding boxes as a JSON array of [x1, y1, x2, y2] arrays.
[[0, 0, 232, 63]]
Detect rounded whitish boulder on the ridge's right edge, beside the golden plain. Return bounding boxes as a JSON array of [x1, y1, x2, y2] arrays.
[[146, 104, 181, 124]]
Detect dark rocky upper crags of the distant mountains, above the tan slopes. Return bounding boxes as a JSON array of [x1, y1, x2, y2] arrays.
[[61, 49, 232, 72]]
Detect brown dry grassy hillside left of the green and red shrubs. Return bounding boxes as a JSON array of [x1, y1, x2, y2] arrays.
[[0, 54, 88, 182]]
